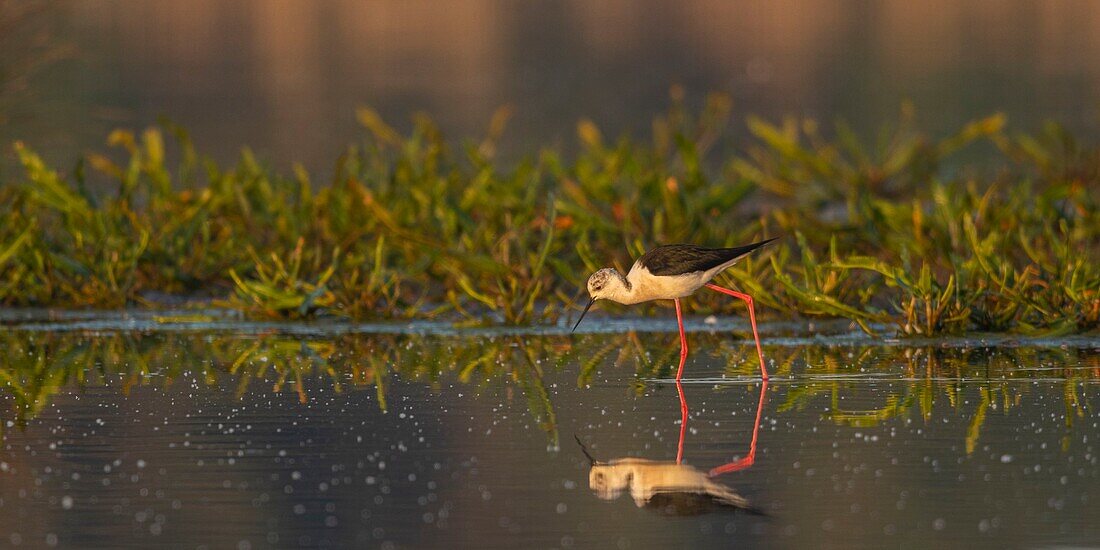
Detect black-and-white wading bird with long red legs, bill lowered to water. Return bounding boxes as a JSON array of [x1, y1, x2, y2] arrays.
[[573, 239, 774, 381]]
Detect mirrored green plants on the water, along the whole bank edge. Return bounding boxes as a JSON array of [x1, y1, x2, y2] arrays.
[[0, 331, 1100, 451]]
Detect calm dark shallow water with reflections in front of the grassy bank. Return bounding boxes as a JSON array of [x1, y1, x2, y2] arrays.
[[0, 321, 1100, 548]]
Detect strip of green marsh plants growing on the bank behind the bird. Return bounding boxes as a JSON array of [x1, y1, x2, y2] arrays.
[[0, 91, 1100, 336]]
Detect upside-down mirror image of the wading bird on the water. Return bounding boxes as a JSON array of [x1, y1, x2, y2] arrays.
[[574, 380, 768, 516]]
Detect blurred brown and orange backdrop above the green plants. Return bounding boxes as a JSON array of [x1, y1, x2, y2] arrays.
[[0, 0, 1100, 175]]
